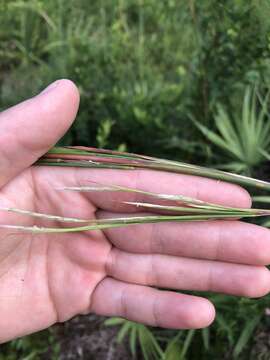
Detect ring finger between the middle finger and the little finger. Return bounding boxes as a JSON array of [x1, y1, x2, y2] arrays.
[[106, 248, 270, 297]]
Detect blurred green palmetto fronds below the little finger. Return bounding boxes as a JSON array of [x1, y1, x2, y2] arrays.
[[105, 295, 269, 360]]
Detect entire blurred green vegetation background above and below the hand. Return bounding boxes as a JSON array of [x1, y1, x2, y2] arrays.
[[0, 0, 270, 360]]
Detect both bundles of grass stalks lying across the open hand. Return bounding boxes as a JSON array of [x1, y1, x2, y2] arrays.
[[0, 147, 270, 234]]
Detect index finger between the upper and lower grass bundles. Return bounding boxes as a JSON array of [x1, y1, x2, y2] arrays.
[[35, 167, 251, 212]]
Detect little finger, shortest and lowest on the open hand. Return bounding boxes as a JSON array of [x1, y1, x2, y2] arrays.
[[91, 278, 215, 329]]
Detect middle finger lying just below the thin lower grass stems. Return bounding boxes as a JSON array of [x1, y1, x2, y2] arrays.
[[97, 211, 270, 265]]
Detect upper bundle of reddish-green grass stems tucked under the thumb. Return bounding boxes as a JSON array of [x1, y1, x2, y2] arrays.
[[36, 147, 270, 190]]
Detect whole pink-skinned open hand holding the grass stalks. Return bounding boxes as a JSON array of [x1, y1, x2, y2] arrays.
[[0, 80, 270, 342]]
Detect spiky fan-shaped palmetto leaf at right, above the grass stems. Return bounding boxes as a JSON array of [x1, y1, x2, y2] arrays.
[[194, 87, 270, 175]]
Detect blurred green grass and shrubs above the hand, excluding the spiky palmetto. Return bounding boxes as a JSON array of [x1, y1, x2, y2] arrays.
[[0, 0, 270, 161]]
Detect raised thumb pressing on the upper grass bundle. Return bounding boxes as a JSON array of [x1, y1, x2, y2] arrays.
[[0, 80, 80, 187]]
